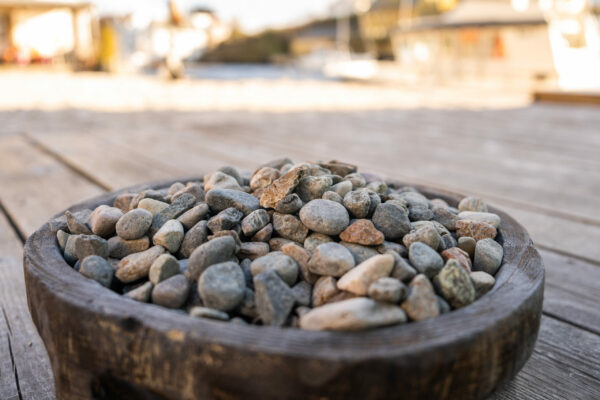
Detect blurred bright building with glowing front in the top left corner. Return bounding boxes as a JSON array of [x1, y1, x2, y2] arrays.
[[0, 0, 98, 67]]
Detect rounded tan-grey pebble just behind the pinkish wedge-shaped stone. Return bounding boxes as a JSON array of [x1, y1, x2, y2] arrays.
[[308, 242, 355, 277]]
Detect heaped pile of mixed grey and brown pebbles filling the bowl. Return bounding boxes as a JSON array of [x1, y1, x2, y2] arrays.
[[51, 158, 503, 330]]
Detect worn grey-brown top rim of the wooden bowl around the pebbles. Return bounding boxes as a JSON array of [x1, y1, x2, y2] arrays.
[[24, 176, 544, 361]]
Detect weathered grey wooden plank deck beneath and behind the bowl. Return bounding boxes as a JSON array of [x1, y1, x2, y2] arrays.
[[0, 72, 600, 400]]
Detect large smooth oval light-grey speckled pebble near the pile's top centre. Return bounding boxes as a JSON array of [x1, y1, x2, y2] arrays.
[[300, 199, 350, 235]]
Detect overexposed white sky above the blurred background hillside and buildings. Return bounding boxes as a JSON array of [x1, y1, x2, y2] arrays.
[[92, 0, 339, 33]]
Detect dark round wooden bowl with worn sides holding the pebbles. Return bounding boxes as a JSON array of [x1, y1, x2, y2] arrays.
[[24, 181, 544, 399]]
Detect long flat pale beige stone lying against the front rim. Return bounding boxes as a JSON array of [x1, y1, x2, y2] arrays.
[[300, 297, 406, 331]]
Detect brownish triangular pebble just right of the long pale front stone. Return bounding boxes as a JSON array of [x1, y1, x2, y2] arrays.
[[401, 274, 440, 321]]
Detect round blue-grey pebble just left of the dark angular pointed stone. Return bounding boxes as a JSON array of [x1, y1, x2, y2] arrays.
[[198, 262, 246, 311]]
